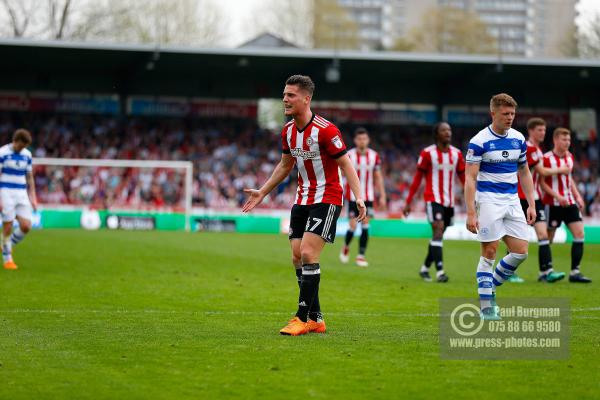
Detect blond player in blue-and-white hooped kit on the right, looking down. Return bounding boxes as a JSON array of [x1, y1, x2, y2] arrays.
[[465, 93, 536, 320]]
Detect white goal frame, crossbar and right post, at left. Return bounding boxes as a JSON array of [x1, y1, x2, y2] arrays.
[[33, 157, 193, 231]]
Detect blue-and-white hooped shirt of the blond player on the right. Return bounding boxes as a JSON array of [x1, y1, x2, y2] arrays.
[[466, 126, 527, 204]]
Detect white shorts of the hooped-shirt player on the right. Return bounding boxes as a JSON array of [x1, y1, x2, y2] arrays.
[[477, 203, 529, 242]]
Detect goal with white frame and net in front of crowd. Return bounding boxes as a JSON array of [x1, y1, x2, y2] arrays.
[[33, 158, 193, 231]]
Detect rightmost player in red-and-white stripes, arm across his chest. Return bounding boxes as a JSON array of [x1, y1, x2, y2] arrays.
[[541, 128, 592, 283]]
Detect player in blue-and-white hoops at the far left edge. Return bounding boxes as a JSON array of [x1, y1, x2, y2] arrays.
[[0, 129, 37, 269]]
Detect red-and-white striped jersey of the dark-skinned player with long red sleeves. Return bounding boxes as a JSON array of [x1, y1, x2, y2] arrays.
[[417, 145, 465, 207]]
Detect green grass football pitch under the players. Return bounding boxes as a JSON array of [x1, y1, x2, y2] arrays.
[[0, 230, 600, 400]]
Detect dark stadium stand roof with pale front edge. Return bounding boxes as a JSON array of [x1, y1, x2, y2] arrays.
[[0, 39, 600, 109]]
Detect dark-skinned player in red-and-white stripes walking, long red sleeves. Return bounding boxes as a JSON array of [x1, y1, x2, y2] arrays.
[[404, 122, 465, 282]]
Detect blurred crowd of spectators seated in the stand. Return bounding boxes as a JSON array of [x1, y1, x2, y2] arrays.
[[0, 114, 600, 217]]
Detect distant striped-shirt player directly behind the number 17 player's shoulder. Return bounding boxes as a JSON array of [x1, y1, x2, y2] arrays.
[[340, 128, 387, 267]]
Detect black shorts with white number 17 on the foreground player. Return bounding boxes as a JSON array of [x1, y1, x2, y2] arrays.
[[289, 203, 342, 243]]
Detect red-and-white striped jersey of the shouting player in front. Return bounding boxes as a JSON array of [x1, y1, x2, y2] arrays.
[[281, 114, 346, 206]]
